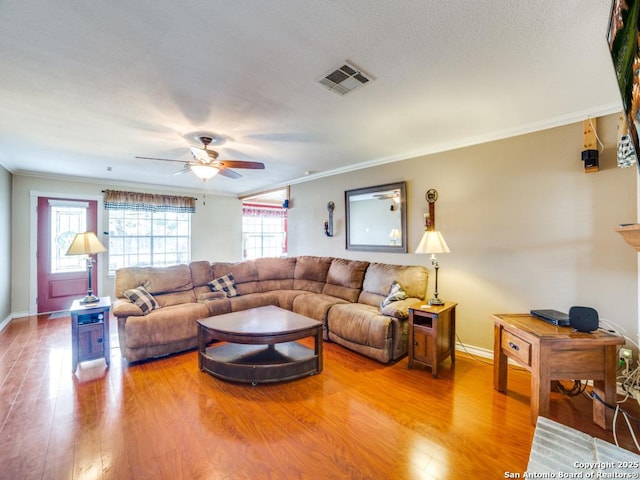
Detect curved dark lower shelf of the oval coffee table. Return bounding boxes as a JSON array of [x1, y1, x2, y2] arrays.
[[200, 342, 320, 385]]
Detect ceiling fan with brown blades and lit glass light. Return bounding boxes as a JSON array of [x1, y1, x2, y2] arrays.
[[136, 136, 264, 182]]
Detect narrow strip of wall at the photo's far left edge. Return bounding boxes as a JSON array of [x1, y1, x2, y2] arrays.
[[0, 165, 12, 326]]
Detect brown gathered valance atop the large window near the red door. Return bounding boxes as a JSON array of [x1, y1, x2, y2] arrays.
[[104, 190, 196, 213]]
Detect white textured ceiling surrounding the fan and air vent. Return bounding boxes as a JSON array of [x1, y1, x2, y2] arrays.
[[0, 0, 621, 194]]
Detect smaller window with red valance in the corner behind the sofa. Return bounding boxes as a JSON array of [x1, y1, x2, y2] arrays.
[[242, 203, 287, 260]]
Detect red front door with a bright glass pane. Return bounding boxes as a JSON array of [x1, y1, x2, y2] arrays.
[[37, 197, 98, 313]]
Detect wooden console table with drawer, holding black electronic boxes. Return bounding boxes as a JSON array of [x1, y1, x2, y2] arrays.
[[491, 314, 624, 429]]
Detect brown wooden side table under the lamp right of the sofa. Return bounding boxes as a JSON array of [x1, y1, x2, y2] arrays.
[[408, 302, 457, 378]]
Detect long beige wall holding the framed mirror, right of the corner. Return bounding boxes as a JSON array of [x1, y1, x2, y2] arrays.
[[289, 116, 638, 349]]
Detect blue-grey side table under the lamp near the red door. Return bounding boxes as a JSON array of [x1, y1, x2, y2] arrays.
[[70, 297, 111, 373]]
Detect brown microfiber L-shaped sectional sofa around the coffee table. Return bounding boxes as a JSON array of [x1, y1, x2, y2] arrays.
[[113, 256, 428, 363]]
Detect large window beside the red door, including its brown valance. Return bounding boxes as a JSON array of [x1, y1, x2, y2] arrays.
[[104, 190, 195, 275]]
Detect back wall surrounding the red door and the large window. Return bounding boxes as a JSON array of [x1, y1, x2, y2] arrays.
[[11, 175, 242, 315]]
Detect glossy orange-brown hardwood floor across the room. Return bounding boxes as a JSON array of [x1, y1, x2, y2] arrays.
[[0, 316, 632, 480]]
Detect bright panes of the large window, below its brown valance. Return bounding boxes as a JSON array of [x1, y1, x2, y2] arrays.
[[109, 210, 191, 274]]
